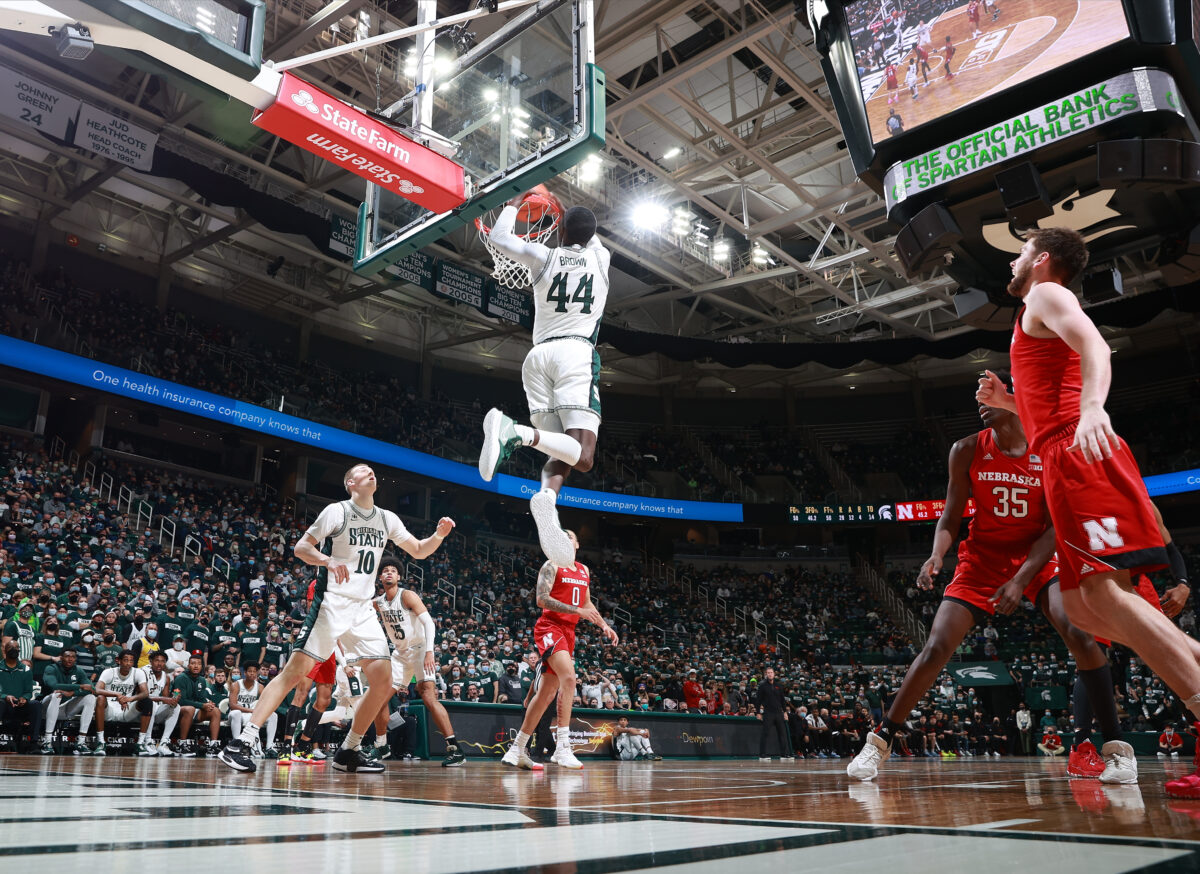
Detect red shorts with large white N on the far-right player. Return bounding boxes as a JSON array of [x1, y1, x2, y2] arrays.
[[1042, 427, 1166, 591]]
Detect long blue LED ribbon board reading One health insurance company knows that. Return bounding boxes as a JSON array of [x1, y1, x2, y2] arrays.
[[0, 335, 742, 522]]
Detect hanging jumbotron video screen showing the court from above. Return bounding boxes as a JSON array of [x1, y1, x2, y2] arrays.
[[845, 0, 1129, 143]]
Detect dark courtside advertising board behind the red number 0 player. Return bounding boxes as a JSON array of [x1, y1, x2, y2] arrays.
[[424, 701, 762, 759]]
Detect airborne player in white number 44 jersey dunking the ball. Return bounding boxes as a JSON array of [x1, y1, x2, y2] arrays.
[[479, 190, 612, 568]]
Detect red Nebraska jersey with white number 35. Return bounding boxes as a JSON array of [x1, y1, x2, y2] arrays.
[[960, 427, 1050, 556]]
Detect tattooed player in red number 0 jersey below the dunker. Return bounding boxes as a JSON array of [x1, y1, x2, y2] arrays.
[[500, 531, 618, 771]]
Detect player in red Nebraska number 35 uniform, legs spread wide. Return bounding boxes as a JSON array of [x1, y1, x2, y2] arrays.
[[846, 381, 1138, 783]]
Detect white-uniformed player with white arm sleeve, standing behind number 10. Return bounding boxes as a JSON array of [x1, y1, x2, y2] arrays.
[[374, 558, 467, 768]]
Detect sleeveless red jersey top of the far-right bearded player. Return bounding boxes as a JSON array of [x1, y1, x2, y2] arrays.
[[1009, 307, 1084, 451]]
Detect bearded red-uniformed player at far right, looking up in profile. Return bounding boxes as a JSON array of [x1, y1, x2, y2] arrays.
[[976, 228, 1200, 797]]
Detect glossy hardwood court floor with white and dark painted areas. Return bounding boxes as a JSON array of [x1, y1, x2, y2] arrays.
[[0, 756, 1200, 874]]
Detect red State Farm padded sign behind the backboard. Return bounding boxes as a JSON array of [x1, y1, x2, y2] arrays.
[[251, 72, 467, 212]]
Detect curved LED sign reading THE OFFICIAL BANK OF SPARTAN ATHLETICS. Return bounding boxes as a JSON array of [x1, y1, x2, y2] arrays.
[[883, 68, 1186, 212]]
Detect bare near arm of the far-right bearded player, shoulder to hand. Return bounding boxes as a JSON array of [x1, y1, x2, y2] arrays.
[[1025, 282, 1117, 463]]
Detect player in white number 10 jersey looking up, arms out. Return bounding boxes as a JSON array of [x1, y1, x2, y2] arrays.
[[220, 465, 454, 773]]
